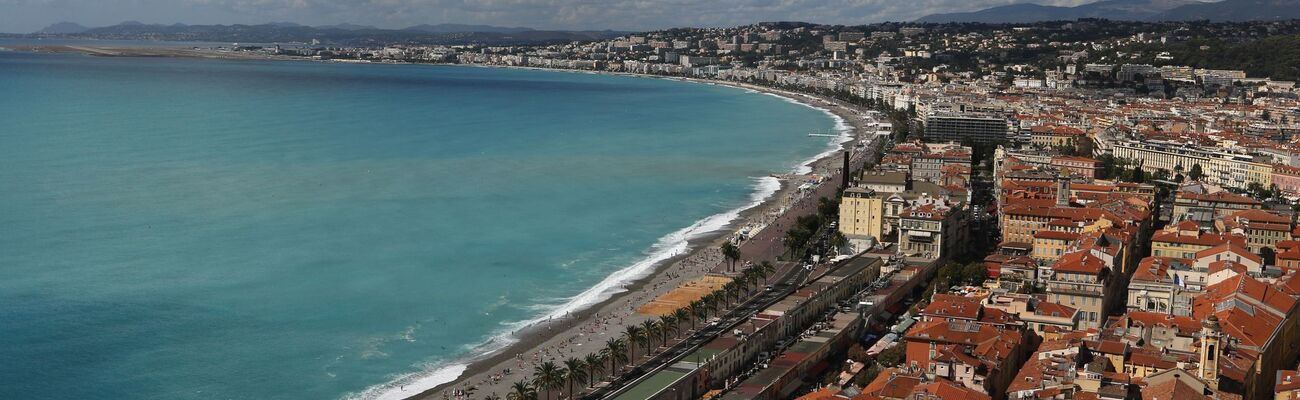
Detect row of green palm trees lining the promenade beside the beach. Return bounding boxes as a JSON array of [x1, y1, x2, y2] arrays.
[[501, 261, 776, 400]]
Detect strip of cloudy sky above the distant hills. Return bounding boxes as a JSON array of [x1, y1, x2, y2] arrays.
[[0, 0, 1091, 32]]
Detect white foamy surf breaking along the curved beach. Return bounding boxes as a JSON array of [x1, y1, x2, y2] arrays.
[[346, 81, 853, 400]]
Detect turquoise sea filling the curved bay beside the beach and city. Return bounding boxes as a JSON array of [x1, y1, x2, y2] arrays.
[[0, 51, 835, 399]]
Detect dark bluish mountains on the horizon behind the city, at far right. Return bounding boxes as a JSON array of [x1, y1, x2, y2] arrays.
[[917, 0, 1300, 23]]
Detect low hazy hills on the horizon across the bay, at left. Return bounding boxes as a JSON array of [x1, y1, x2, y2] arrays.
[[25, 21, 627, 44]]
